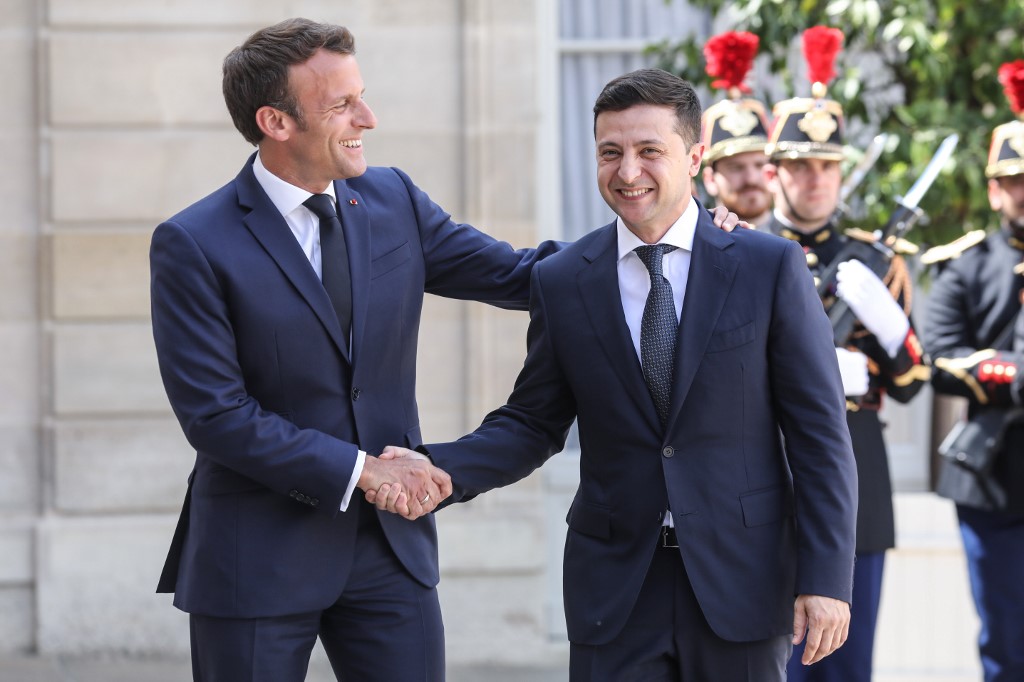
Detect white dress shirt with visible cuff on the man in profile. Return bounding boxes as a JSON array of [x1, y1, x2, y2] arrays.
[[253, 154, 367, 503]]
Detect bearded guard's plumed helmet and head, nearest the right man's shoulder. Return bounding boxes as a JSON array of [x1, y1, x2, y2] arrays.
[[701, 31, 771, 227]]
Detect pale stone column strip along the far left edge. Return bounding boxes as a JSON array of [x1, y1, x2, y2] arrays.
[[0, 0, 43, 651]]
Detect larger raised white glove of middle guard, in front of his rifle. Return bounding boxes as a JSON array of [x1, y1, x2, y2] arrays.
[[836, 260, 910, 357]]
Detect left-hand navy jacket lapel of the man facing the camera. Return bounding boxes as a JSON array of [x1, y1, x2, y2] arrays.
[[577, 223, 660, 429]]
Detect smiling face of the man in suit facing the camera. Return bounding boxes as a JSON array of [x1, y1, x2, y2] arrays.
[[595, 104, 703, 244]]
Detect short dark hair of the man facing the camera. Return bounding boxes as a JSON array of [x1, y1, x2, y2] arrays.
[[594, 69, 700, 145]]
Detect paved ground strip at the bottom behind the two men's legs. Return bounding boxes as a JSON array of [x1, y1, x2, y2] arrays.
[[0, 656, 568, 682]]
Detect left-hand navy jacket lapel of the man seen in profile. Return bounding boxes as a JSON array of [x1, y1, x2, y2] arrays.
[[234, 155, 355, 359]]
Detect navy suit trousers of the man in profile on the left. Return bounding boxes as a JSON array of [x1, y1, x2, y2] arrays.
[[189, 498, 444, 682]]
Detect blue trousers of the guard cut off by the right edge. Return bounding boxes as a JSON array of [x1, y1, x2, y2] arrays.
[[956, 501, 1024, 682]]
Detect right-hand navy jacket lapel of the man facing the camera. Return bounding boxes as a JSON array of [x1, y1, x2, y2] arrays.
[[667, 210, 741, 428]]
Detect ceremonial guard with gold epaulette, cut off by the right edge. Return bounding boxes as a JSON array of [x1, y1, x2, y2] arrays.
[[922, 60, 1024, 682]]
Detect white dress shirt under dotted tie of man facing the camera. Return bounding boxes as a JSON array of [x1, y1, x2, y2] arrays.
[[615, 199, 699, 527]]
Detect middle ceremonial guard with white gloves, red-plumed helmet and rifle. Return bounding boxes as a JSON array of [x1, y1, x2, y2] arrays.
[[765, 27, 928, 682]]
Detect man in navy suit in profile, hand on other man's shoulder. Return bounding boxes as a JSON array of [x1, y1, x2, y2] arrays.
[[151, 19, 557, 682]]
